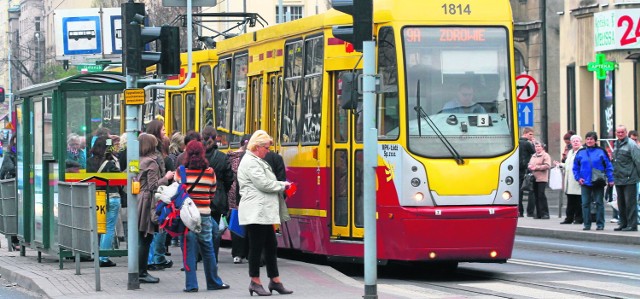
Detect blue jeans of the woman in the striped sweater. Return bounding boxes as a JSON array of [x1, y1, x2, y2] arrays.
[[182, 216, 222, 290]]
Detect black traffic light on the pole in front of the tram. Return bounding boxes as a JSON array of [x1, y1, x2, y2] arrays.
[[331, 0, 373, 52]]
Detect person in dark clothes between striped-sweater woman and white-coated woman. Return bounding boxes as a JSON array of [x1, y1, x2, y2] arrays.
[[202, 126, 233, 260]]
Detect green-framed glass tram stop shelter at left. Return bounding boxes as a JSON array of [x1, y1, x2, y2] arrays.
[[13, 72, 127, 267]]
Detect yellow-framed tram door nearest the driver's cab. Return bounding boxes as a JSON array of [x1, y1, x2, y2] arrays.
[[330, 72, 364, 240]]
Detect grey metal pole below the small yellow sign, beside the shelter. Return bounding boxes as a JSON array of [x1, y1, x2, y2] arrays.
[[125, 75, 140, 290]]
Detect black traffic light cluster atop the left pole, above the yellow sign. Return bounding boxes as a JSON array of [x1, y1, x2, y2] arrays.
[[122, 2, 180, 75]]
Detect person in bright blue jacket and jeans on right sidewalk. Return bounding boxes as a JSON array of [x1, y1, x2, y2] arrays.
[[573, 132, 614, 230]]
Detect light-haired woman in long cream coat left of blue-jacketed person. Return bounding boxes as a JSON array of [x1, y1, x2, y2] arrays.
[[555, 135, 582, 224]]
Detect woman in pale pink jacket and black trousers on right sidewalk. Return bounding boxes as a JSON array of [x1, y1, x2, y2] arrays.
[[528, 141, 551, 219]]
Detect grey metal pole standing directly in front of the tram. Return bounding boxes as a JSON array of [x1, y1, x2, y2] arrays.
[[362, 41, 378, 299]]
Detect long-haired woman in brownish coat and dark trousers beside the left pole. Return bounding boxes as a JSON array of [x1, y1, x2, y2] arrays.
[[137, 133, 173, 283]]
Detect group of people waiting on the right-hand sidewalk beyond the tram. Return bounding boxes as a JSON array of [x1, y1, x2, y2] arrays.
[[518, 125, 640, 231]]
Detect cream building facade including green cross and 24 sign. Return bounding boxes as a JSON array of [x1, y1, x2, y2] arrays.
[[559, 0, 640, 146]]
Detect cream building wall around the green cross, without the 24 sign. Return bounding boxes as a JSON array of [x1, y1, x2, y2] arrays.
[[558, 0, 640, 145]]
